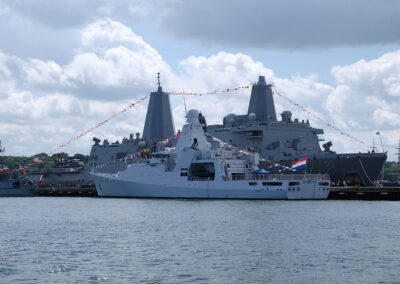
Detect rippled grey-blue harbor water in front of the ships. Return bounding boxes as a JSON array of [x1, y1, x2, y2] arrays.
[[0, 197, 400, 283]]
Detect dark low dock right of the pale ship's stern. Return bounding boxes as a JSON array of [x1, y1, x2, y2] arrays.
[[328, 186, 400, 200]]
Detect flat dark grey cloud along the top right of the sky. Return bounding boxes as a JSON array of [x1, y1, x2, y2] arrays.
[[159, 0, 400, 49]]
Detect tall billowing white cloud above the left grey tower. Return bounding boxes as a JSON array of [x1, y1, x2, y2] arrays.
[[7, 19, 174, 100]]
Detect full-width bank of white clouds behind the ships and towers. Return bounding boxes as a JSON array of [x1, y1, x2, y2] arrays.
[[0, 19, 400, 161]]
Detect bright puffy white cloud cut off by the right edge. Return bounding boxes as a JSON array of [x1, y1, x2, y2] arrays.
[[326, 50, 400, 134]]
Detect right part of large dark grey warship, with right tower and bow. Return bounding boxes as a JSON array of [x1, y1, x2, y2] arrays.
[[207, 76, 387, 186]]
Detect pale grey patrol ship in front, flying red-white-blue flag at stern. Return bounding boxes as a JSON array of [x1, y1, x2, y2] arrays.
[[93, 110, 330, 199]]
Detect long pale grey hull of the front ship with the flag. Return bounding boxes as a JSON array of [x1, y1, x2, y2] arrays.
[[94, 175, 329, 199]]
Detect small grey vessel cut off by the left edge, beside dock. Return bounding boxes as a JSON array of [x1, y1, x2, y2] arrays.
[[0, 141, 37, 197]]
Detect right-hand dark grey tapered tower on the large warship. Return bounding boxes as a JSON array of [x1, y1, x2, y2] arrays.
[[247, 76, 276, 121]]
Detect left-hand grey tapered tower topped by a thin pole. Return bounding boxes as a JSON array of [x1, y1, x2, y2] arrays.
[[143, 73, 175, 144]]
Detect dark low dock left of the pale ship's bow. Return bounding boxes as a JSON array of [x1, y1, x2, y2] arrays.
[[37, 186, 97, 197]]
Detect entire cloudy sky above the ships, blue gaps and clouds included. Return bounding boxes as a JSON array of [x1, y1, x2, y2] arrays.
[[0, 0, 400, 160]]
